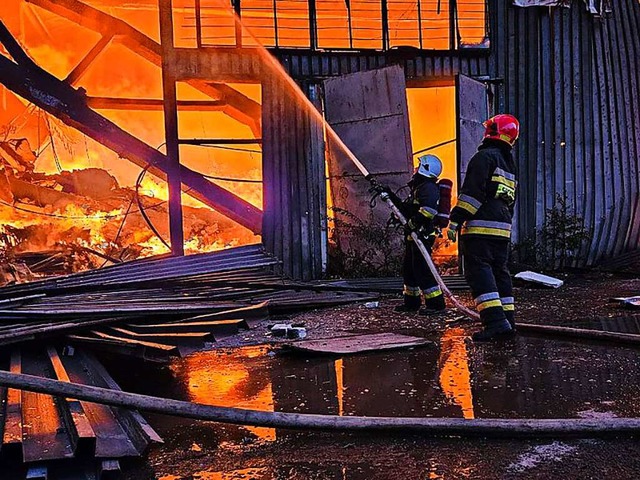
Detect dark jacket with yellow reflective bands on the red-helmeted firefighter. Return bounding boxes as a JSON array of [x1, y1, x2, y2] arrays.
[[451, 139, 518, 240]]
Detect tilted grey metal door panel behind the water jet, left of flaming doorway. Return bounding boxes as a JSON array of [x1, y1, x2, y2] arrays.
[[325, 66, 413, 260]]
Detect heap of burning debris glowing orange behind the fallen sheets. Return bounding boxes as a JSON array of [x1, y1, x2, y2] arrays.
[[0, 139, 258, 284]]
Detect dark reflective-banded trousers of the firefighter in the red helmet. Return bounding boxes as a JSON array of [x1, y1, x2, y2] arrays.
[[460, 235, 515, 326]]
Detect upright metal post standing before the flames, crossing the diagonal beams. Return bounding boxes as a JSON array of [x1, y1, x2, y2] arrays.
[[158, 0, 184, 256]]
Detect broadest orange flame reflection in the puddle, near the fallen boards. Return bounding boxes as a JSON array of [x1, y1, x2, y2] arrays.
[[184, 347, 276, 440]]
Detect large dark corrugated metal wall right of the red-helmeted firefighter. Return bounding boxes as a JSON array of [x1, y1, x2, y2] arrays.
[[490, 0, 640, 265]]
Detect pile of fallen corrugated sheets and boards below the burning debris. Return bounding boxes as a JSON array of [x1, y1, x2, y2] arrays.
[[0, 245, 378, 354]]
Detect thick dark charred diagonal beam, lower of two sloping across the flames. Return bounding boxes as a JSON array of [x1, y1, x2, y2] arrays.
[[0, 56, 262, 233]]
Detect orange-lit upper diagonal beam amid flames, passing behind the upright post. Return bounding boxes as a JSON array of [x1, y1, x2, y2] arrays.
[[27, 0, 262, 136]]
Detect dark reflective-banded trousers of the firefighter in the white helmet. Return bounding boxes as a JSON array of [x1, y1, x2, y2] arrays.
[[402, 235, 445, 310]]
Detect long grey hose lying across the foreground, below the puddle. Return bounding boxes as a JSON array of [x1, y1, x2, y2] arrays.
[[0, 371, 640, 438]]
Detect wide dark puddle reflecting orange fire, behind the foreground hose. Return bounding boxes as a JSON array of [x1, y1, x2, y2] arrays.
[[107, 329, 640, 446]]
